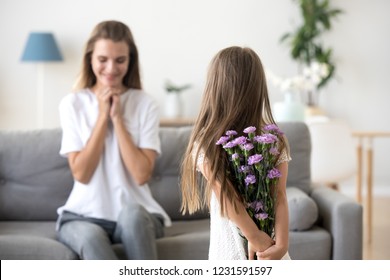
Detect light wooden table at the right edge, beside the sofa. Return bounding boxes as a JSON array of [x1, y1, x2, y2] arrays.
[[352, 131, 390, 242]]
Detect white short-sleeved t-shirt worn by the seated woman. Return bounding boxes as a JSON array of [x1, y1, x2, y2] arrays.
[[57, 89, 171, 226]]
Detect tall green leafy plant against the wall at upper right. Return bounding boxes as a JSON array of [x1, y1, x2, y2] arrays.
[[281, 0, 343, 106]]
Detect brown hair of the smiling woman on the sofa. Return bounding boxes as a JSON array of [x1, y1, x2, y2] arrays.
[[75, 20, 142, 90]]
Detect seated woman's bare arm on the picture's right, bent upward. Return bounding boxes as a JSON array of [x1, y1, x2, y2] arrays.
[[110, 95, 157, 185]]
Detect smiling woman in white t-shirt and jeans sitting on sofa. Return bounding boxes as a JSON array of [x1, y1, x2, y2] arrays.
[[58, 21, 170, 259]]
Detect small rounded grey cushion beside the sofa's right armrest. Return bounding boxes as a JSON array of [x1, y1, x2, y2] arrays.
[[286, 187, 318, 231]]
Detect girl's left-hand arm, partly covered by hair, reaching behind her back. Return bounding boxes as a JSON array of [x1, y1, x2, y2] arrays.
[[199, 161, 274, 260]]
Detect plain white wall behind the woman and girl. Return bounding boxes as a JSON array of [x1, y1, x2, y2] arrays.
[[0, 0, 390, 186]]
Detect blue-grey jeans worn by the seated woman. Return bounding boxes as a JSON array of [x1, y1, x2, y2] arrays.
[[58, 204, 164, 260]]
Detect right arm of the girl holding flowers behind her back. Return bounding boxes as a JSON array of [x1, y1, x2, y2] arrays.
[[257, 161, 289, 260]]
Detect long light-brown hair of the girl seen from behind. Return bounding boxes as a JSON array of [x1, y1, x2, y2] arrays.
[[181, 47, 287, 217]]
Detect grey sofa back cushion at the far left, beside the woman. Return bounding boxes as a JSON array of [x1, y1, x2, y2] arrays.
[[0, 129, 73, 221]]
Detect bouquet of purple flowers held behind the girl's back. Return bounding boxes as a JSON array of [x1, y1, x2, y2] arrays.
[[216, 124, 283, 238]]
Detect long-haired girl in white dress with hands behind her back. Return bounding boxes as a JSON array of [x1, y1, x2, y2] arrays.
[[181, 47, 290, 259]]
